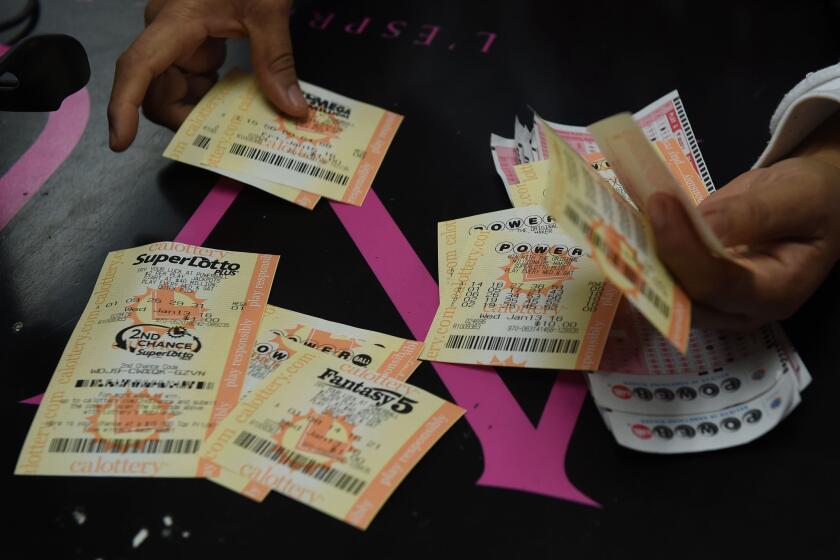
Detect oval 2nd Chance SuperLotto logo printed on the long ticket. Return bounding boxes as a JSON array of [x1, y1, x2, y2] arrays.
[[114, 323, 201, 360]]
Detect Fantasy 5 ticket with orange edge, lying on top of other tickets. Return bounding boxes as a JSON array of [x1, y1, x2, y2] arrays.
[[202, 348, 464, 529]]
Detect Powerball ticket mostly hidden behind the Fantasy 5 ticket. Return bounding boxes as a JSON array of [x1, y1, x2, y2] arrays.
[[243, 305, 423, 396]]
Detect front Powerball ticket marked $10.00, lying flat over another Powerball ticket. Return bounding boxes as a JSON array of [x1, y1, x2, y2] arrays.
[[420, 229, 619, 370]]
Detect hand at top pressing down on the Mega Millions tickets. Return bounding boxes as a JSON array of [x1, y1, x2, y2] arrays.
[[108, 0, 308, 152]]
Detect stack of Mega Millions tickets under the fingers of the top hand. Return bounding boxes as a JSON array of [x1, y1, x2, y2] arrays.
[[163, 70, 402, 209]]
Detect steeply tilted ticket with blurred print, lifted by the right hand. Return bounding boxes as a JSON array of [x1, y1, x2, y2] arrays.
[[537, 118, 691, 352]]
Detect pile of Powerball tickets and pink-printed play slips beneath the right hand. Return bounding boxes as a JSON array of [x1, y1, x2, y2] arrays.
[[421, 91, 810, 453]]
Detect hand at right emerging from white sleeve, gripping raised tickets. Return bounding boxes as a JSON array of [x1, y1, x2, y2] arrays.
[[647, 150, 840, 330]]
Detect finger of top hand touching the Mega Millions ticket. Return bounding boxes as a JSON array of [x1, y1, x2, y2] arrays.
[[243, 1, 309, 117]]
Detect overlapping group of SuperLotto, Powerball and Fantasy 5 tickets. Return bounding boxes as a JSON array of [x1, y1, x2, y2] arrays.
[[15, 242, 463, 529]]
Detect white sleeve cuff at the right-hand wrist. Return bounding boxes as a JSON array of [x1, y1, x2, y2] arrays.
[[753, 64, 840, 167]]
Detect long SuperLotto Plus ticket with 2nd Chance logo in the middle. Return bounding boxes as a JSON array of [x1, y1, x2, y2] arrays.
[[15, 242, 278, 477]]
